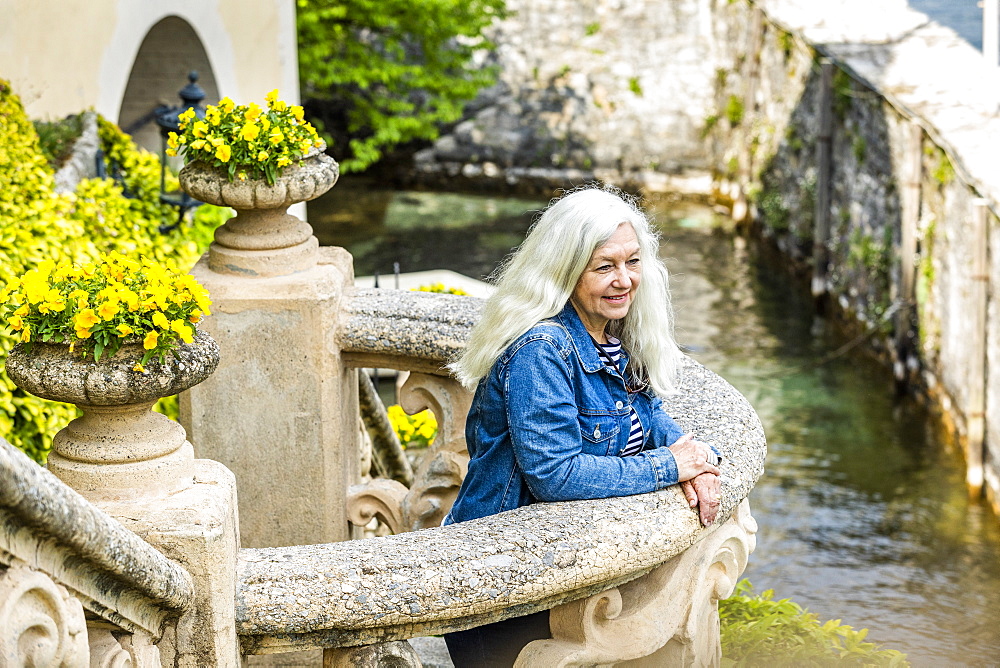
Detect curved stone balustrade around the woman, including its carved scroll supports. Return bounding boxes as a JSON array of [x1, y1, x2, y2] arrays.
[[237, 289, 766, 665]]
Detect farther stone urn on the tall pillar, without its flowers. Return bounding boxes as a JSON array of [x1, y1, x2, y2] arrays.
[[179, 147, 340, 277]]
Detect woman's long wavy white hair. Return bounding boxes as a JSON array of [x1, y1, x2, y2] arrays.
[[449, 185, 681, 396]]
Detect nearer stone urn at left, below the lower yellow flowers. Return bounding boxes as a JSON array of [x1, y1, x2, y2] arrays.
[[7, 332, 219, 502]]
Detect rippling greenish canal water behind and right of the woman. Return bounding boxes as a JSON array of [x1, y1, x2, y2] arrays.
[[309, 179, 1000, 666]]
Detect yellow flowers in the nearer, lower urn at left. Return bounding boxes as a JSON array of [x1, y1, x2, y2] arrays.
[[0, 251, 211, 371]]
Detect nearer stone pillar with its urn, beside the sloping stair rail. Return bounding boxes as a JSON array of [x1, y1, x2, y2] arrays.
[[6, 332, 241, 668]]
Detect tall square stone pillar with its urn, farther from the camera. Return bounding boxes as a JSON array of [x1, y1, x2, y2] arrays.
[[181, 154, 360, 547]]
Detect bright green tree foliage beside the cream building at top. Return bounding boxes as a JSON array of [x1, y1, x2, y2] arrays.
[[297, 0, 506, 172]]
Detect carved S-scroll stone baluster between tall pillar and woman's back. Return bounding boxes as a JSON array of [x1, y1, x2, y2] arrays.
[[347, 373, 472, 533]]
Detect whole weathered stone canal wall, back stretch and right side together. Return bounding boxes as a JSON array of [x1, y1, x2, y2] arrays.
[[416, 0, 1000, 507]]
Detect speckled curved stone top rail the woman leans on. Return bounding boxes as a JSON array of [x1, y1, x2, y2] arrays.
[[237, 360, 766, 653]]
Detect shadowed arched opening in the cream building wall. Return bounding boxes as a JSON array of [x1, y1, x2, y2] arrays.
[[118, 16, 219, 152]]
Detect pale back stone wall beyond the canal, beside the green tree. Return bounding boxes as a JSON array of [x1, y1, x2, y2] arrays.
[[417, 0, 714, 194]]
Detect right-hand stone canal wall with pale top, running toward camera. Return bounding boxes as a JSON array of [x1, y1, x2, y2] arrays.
[[709, 0, 1000, 505]]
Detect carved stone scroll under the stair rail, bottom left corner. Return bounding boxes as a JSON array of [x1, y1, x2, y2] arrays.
[[0, 564, 90, 668]]
